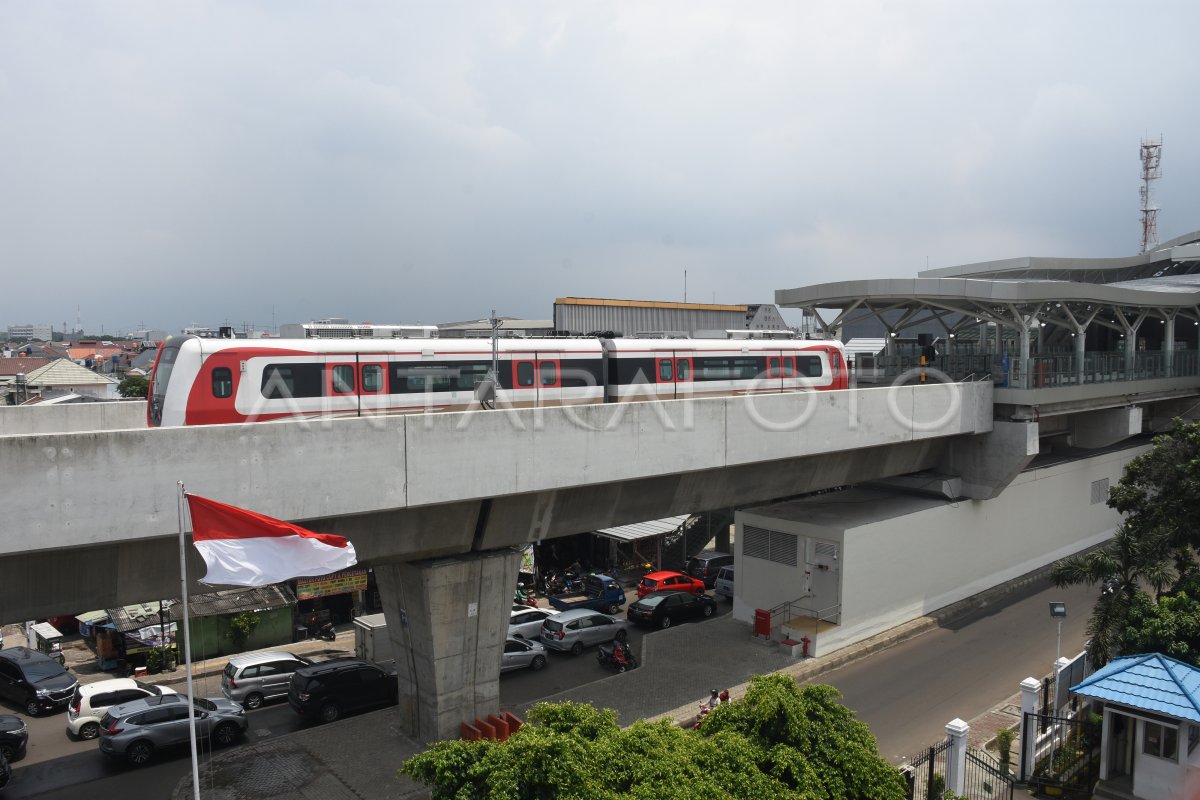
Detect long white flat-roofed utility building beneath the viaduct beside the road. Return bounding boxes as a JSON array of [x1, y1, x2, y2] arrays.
[[734, 447, 1147, 652]]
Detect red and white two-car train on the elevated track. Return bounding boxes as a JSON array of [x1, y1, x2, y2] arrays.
[[146, 336, 848, 427]]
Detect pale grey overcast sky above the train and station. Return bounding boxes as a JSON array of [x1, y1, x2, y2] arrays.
[[0, 0, 1200, 332]]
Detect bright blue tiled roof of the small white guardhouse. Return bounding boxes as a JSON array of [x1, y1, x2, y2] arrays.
[[1070, 652, 1200, 723]]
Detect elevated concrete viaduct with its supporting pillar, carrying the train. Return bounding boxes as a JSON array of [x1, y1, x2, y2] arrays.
[[0, 383, 993, 739]]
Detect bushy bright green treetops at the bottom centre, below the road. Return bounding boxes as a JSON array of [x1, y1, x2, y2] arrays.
[[401, 675, 905, 800]]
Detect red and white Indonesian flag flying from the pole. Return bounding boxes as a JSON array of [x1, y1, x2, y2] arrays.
[[186, 493, 356, 587]]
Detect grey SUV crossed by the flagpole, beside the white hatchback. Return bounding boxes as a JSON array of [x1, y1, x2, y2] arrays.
[[100, 694, 250, 766]]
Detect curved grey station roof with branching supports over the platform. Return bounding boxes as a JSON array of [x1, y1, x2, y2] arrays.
[[775, 231, 1200, 338]]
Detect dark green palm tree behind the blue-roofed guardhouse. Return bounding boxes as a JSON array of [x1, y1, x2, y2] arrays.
[[1050, 521, 1174, 667]]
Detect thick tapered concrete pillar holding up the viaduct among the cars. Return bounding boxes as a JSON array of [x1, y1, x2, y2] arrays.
[[374, 548, 521, 741]]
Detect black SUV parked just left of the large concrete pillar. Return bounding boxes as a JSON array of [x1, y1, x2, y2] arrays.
[[288, 658, 400, 722]]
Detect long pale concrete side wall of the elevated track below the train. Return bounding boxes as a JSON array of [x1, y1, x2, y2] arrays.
[[0, 384, 991, 554]]
